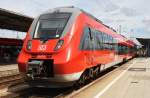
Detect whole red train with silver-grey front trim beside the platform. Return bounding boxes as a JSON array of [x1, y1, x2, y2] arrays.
[[18, 7, 135, 87]]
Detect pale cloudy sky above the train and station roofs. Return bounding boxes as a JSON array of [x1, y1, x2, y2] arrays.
[[0, 0, 150, 38]]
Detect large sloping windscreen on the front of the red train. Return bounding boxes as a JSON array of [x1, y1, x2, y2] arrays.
[[33, 13, 71, 40]]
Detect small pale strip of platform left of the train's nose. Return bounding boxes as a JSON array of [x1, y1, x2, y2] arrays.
[[0, 64, 19, 77]]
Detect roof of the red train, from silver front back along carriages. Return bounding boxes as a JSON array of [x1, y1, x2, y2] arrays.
[[44, 6, 134, 46]]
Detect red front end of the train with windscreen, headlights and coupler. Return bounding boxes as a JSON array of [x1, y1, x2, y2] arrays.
[[18, 9, 81, 86]]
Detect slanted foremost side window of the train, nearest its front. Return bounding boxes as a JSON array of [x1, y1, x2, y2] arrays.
[[80, 27, 92, 50]]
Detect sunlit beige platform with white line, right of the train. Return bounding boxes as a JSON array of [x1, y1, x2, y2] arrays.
[[72, 58, 150, 98]]
